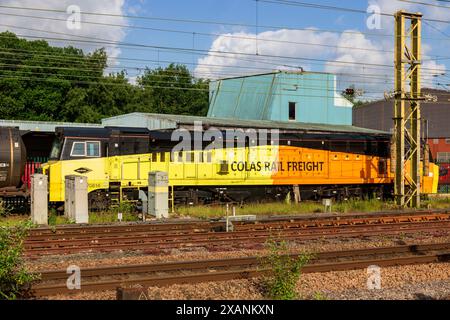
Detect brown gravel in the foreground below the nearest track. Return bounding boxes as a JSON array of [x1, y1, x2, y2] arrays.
[[44, 263, 450, 300]]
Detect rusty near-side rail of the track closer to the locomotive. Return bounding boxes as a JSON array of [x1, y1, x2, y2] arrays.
[[25, 222, 450, 255]]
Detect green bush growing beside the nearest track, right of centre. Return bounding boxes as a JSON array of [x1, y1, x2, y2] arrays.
[[262, 240, 311, 300]]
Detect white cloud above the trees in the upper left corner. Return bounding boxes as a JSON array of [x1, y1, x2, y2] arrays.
[[0, 0, 127, 65]]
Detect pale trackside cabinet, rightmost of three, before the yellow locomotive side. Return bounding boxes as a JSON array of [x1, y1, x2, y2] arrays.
[[148, 171, 169, 219]]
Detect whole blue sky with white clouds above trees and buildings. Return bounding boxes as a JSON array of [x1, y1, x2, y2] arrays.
[[0, 0, 450, 98]]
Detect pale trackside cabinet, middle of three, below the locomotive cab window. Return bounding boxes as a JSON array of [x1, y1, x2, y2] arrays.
[[64, 176, 89, 224]]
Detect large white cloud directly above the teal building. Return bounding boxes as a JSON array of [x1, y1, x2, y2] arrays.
[[195, 29, 338, 78]]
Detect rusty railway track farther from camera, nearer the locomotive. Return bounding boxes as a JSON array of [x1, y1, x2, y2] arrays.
[[25, 213, 450, 256]]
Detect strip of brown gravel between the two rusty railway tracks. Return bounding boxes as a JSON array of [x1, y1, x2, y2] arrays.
[[27, 233, 450, 271]]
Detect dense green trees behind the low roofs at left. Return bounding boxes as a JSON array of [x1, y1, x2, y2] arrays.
[[0, 32, 209, 123]]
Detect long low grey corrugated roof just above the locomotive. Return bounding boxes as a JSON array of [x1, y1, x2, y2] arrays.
[[102, 113, 389, 134]]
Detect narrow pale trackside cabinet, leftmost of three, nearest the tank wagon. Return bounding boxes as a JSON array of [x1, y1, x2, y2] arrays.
[[31, 174, 48, 225]]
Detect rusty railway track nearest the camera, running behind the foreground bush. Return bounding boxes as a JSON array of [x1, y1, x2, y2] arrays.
[[32, 243, 450, 297]]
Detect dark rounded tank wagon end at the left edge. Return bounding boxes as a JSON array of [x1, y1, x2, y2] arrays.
[[0, 128, 26, 189]]
